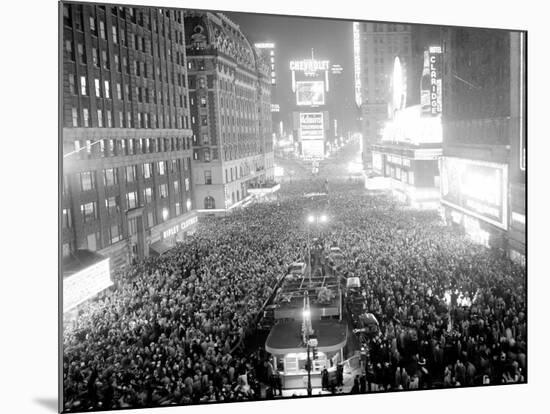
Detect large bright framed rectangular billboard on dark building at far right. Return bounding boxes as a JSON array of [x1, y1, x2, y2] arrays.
[[441, 157, 508, 230]]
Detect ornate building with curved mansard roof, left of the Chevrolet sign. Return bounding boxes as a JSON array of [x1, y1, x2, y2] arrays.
[[185, 10, 274, 212]]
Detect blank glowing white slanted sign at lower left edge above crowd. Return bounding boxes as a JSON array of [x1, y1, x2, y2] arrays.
[[63, 258, 113, 312]]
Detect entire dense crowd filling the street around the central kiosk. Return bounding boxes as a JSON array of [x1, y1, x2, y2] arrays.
[[63, 175, 527, 411]]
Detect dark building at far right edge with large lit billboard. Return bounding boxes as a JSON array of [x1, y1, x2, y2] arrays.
[[441, 28, 526, 262]]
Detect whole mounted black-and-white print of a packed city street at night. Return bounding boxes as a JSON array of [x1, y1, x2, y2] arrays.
[[59, 1, 527, 412]]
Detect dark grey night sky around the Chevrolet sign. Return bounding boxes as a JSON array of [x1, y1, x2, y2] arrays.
[[224, 12, 356, 134]]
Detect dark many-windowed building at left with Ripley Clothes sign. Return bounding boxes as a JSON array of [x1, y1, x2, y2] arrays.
[[60, 2, 197, 278]]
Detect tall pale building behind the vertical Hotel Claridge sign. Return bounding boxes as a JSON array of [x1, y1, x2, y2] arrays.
[[353, 22, 412, 166]]
